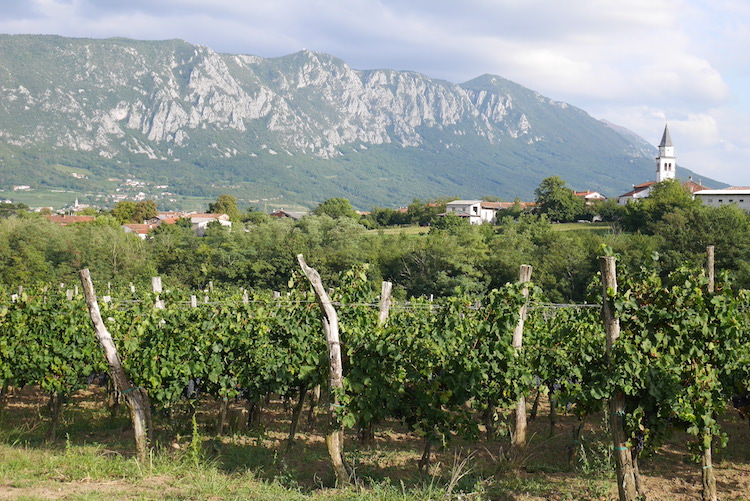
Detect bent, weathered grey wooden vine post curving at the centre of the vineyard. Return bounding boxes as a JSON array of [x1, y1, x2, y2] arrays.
[[297, 254, 354, 485]]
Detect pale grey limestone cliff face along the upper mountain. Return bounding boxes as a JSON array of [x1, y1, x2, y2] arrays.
[[0, 38, 592, 158]]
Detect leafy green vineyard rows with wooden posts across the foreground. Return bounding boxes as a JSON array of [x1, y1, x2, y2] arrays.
[[0, 254, 750, 499]]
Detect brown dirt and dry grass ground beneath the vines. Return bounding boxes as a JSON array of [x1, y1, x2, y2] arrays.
[[0, 387, 750, 501]]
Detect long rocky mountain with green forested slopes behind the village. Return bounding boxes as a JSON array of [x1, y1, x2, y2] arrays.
[[0, 35, 724, 208]]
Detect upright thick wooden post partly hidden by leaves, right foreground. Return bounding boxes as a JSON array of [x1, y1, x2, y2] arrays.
[[599, 256, 638, 501]]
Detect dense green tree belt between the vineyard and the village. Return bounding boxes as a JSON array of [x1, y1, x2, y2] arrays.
[[0, 180, 750, 301]]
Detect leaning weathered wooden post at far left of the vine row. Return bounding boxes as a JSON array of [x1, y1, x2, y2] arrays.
[[80, 269, 149, 462]]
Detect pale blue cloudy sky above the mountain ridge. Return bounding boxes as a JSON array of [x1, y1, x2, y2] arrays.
[[0, 0, 750, 186]]
